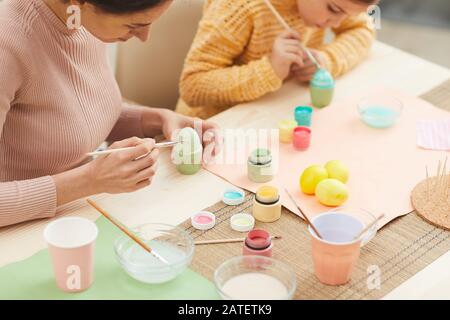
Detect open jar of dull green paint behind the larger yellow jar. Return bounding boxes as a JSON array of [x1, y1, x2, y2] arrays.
[[247, 148, 274, 183]]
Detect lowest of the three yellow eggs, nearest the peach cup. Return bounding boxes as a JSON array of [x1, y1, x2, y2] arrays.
[[316, 179, 349, 207]]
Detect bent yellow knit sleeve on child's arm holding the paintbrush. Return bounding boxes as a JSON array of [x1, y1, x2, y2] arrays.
[[180, 0, 282, 107]]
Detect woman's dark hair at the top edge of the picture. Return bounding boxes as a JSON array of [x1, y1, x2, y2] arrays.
[[80, 0, 168, 14]]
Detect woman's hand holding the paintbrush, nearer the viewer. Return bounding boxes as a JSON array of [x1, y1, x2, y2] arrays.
[[87, 137, 159, 194]]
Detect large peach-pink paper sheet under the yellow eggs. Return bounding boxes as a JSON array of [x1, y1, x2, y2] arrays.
[[206, 88, 450, 228]]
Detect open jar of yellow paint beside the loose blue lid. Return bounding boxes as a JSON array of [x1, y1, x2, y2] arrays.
[[252, 186, 281, 222]]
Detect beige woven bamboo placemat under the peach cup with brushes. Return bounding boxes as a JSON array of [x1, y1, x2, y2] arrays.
[[181, 80, 450, 300]]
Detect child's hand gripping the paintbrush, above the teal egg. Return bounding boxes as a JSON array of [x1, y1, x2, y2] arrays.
[[269, 30, 304, 80]]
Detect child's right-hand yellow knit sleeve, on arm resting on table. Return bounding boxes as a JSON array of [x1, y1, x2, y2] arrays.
[[319, 13, 376, 77]]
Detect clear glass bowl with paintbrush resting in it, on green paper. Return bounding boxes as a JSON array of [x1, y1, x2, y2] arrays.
[[114, 223, 194, 284]]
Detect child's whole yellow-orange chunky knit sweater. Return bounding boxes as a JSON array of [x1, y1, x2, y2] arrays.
[[177, 0, 375, 119]]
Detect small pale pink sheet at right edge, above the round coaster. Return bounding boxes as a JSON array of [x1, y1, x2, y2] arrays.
[[417, 119, 450, 151]]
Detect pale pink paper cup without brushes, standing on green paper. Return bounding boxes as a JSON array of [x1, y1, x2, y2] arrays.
[[44, 217, 98, 292]]
